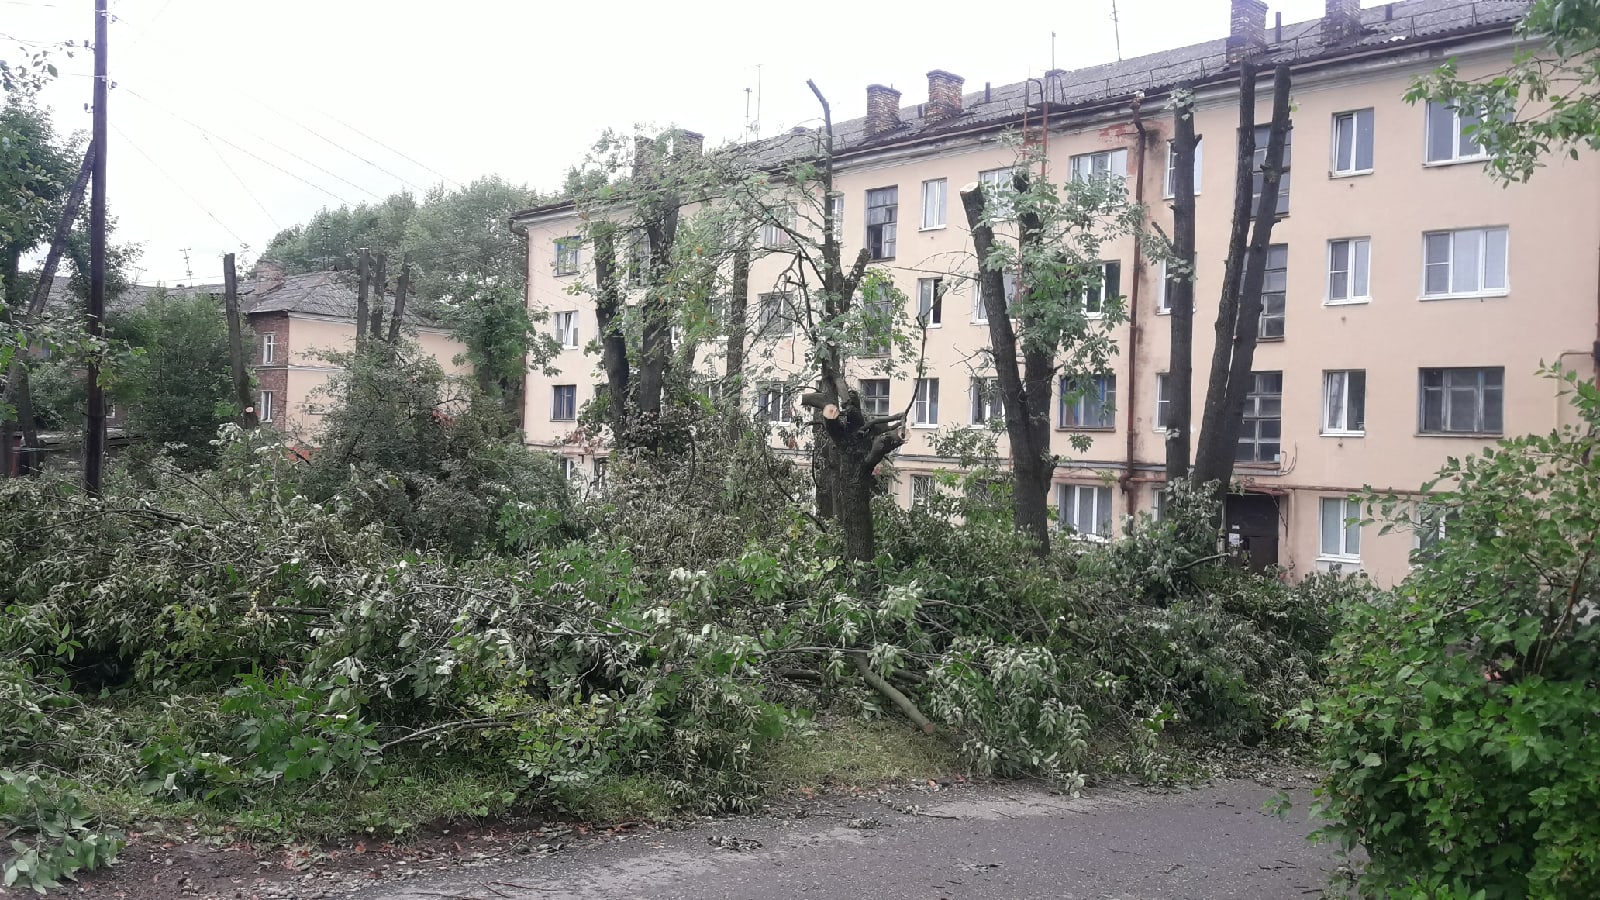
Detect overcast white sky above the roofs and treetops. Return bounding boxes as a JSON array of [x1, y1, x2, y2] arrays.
[[9, 0, 1337, 283]]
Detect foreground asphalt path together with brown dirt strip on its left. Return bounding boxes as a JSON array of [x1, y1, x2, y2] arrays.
[[31, 775, 1336, 900]]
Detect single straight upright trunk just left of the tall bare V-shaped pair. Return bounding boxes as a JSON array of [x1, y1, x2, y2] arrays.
[[1166, 90, 1203, 484]]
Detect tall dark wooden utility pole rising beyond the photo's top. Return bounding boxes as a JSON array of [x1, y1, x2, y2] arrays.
[[83, 0, 110, 496]]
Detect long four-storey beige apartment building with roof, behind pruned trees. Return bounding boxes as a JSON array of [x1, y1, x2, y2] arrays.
[[514, 0, 1600, 583]]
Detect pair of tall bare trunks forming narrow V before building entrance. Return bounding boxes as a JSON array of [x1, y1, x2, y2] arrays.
[[1192, 62, 1290, 498]]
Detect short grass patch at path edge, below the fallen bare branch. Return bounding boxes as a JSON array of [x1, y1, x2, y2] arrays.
[[760, 716, 962, 790]]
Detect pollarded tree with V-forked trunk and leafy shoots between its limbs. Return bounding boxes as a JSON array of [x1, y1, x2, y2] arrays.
[[962, 152, 1144, 554]]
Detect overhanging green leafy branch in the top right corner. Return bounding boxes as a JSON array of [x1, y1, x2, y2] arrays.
[[1406, 0, 1600, 183]]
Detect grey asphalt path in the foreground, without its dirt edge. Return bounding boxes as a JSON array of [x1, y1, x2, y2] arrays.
[[357, 781, 1333, 900]]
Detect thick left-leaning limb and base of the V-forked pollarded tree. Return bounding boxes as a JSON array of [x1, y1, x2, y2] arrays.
[[962, 173, 1056, 556]]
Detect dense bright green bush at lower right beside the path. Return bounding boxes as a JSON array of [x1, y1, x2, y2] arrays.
[[1301, 366, 1600, 898]]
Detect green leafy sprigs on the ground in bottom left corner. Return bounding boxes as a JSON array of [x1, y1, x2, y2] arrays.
[[0, 769, 123, 894]]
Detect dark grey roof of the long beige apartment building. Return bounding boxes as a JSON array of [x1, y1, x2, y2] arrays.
[[512, 0, 1531, 219]]
